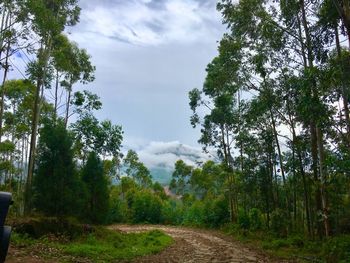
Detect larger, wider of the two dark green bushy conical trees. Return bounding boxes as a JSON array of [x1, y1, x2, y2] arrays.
[[33, 120, 86, 219]]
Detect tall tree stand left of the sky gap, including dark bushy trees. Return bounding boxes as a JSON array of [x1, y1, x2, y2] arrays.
[[0, 0, 123, 219]]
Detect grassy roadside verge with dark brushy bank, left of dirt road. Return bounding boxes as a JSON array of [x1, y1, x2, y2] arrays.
[[11, 218, 173, 262]]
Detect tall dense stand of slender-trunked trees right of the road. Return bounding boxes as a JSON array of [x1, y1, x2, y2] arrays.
[[189, 0, 350, 238]]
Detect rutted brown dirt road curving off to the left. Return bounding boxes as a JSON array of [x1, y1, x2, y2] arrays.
[[110, 225, 287, 263]]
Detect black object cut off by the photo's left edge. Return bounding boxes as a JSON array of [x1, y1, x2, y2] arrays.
[[0, 192, 12, 263]]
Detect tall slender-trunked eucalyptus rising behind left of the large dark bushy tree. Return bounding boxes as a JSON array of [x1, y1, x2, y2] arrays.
[[25, 0, 80, 213]]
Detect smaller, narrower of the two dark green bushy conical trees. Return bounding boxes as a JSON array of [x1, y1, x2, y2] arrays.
[[82, 152, 109, 223]]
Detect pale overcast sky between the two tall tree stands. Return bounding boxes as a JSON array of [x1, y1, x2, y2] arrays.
[[68, 0, 224, 153]]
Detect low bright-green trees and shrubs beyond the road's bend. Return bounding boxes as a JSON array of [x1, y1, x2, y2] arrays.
[[108, 156, 230, 228]]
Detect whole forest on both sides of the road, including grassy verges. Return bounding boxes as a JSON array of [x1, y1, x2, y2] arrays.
[[0, 0, 350, 262]]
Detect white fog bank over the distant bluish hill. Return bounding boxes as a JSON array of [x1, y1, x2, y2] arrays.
[[123, 141, 216, 184]]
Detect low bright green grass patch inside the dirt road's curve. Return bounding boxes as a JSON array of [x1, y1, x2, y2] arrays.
[[11, 227, 173, 262]]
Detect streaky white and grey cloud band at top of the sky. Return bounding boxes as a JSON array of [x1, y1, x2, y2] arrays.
[[75, 0, 221, 45]]
